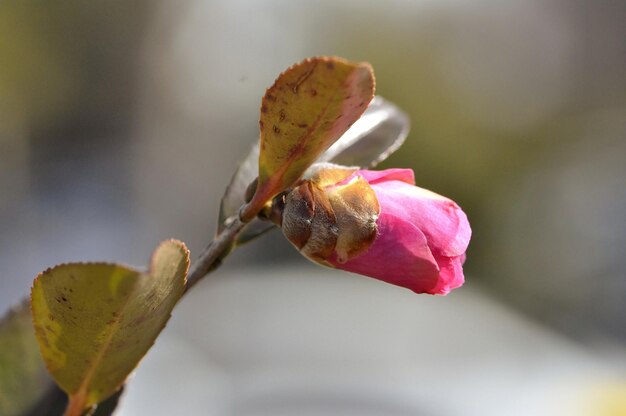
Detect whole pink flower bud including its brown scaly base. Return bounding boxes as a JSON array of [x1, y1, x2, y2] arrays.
[[279, 168, 471, 295]]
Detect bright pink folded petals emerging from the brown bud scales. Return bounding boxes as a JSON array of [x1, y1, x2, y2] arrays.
[[329, 169, 472, 295]]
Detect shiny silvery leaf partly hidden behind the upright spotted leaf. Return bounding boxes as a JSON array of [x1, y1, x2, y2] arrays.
[[219, 96, 410, 245]]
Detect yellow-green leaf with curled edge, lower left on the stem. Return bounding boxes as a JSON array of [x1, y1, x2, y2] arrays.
[[31, 240, 189, 414]]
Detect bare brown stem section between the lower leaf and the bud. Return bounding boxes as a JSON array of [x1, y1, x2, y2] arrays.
[[185, 215, 246, 293]]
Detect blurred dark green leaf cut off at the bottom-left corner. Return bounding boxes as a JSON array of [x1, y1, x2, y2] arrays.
[[0, 300, 54, 416]]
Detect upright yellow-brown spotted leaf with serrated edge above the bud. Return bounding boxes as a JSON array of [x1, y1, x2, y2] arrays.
[[241, 57, 375, 221]]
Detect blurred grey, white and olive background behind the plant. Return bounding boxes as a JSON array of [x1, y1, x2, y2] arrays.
[[0, 0, 626, 415]]
